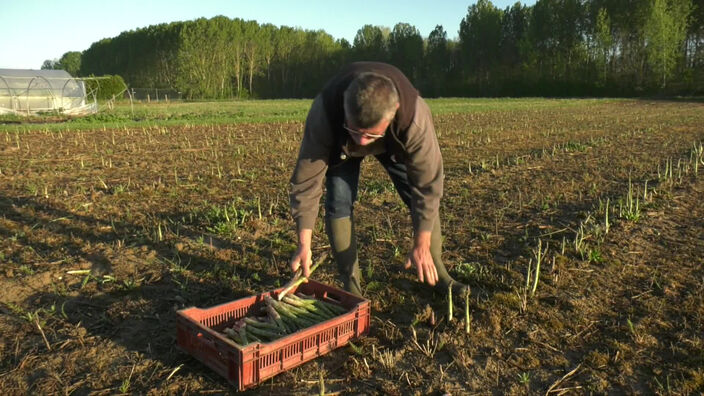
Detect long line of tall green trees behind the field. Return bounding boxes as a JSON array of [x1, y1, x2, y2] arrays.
[[44, 0, 704, 99]]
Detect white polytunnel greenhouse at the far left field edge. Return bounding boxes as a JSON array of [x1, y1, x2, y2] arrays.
[[0, 69, 98, 115]]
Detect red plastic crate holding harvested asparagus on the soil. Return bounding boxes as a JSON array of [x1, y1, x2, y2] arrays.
[[176, 280, 370, 390]]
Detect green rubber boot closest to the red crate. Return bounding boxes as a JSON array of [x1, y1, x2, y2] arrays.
[[325, 217, 362, 297]]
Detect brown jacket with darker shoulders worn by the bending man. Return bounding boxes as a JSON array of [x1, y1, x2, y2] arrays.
[[290, 62, 444, 231]]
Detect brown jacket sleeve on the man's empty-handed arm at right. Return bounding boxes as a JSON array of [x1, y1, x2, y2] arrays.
[[406, 97, 444, 232]]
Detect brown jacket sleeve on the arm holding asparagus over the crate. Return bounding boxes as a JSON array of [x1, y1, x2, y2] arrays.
[[289, 95, 333, 231]]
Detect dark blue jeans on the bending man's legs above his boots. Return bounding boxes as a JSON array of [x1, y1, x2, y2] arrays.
[[325, 153, 411, 219]]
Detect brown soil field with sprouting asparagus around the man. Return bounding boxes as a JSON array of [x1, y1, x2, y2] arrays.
[[0, 100, 704, 395]]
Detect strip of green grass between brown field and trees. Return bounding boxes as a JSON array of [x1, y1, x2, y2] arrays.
[[0, 98, 618, 132]]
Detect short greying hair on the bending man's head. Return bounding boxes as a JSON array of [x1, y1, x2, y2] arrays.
[[344, 72, 398, 128]]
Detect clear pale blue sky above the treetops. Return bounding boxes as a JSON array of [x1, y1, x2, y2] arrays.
[[0, 0, 534, 69]]
